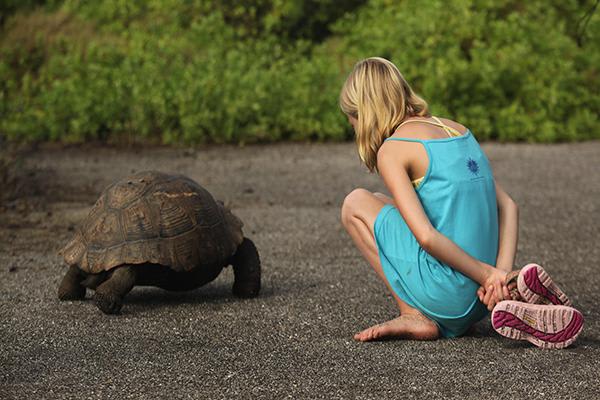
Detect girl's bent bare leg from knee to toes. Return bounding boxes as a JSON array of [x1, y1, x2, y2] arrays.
[[342, 189, 439, 341]]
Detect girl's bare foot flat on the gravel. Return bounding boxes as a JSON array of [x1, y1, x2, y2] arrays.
[[354, 314, 440, 342]]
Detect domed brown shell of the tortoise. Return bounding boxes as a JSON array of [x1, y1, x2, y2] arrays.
[[61, 171, 243, 273]]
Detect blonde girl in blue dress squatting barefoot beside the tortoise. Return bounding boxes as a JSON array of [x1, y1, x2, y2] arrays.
[[340, 57, 584, 341]]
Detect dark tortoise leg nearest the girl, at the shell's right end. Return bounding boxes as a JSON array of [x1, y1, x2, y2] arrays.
[[231, 238, 260, 297]]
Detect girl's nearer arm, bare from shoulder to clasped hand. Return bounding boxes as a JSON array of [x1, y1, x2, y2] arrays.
[[377, 142, 510, 308]]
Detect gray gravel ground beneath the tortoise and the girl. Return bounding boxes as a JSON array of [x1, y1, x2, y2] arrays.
[[0, 142, 600, 399]]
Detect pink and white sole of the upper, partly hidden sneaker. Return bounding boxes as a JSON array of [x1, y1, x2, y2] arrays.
[[517, 264, 573, 307]]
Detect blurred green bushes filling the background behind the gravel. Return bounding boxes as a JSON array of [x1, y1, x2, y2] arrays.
[[0, 0, 600, 143]]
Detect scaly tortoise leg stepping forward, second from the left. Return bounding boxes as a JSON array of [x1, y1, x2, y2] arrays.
[[94, 265, 136, 314]]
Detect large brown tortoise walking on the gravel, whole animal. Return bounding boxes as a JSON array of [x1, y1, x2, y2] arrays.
[[58, 171, 261, 314]]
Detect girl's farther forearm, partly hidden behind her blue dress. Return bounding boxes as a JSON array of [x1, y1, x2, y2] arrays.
[[496, 183, 519, 272]]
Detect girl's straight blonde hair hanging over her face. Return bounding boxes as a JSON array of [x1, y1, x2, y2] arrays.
[[340, 57, 430, 172]]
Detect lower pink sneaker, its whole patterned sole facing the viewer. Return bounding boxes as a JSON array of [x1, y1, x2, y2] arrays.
[[492, 300, 583, 349]]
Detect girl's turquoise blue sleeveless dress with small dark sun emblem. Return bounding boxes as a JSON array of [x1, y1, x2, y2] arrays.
[[374, 120, 498, 337]]
